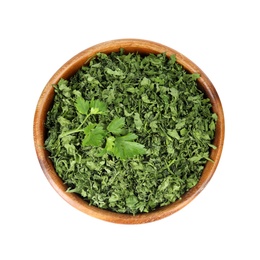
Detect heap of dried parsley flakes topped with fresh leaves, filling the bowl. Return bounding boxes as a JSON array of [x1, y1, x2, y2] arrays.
[[45, 49, 217, 214]]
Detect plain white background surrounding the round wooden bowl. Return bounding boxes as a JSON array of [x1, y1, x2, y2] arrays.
[[0, 0, 260, 260]]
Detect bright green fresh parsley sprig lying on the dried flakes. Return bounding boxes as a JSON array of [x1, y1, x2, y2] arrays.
[[59, 96, 146, 159]]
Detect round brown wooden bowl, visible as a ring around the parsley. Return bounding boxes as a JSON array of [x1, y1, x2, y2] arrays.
[[33, 39, 224, 224]]
